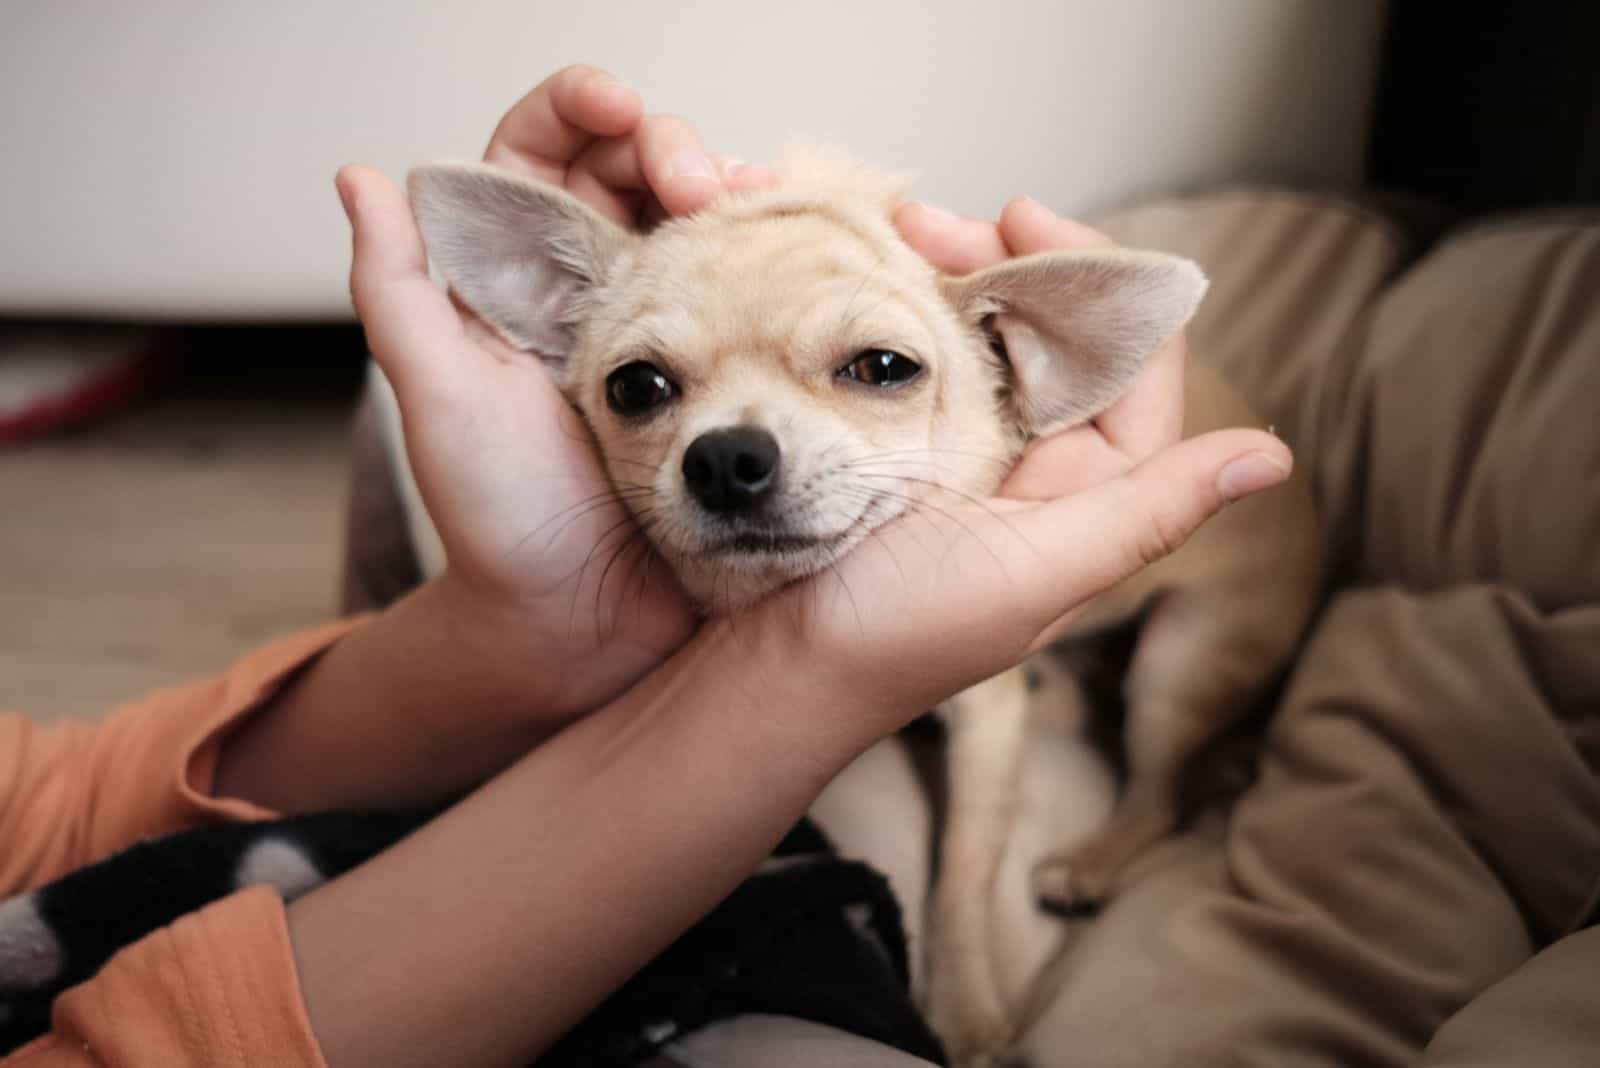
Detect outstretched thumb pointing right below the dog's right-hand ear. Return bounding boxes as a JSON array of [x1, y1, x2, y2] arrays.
[[1013, 430, 1294, 648]]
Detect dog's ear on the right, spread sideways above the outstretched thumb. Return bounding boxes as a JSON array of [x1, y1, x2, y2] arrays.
[[944, 249, 1206, 435]]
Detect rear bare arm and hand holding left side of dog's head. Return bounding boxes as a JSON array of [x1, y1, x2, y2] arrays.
[[216, 66, 771, 812]]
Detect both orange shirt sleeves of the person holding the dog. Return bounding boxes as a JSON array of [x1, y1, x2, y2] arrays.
[[0, 622, 354, 1068]]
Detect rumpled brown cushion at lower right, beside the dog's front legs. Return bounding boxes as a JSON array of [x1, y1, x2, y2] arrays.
[[1022, 585, 1600, 1068]]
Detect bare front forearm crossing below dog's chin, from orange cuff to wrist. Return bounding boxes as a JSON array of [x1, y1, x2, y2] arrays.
[[290, 627, 870, 1068]]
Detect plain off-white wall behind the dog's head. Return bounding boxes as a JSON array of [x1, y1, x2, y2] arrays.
[[0, 0, 1382, 318]]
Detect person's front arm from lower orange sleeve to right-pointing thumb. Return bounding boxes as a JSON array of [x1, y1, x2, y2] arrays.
[[0, 412, 1286, 1068]]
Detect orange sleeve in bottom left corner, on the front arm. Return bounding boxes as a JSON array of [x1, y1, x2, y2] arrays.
[[0, 887, 326, 1068]]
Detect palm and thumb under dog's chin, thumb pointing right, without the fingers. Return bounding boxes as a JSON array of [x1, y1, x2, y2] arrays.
[[742, 415, 1293, 758]]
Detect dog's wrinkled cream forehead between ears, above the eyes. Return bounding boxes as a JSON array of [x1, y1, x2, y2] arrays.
[[602, 203, 941, 362]]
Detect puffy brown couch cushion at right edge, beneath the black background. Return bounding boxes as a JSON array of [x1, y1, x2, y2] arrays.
[[1314, 216, 1600, 609]]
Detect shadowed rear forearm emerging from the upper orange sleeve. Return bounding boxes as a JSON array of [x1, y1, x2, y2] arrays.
[[213, 580, 565, 812]]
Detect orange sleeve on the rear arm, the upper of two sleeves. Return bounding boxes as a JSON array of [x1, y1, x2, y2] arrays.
[[0, 620, 360, 899]]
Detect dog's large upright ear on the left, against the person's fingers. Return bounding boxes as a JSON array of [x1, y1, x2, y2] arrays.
[[406, 163, 637, 368]]
